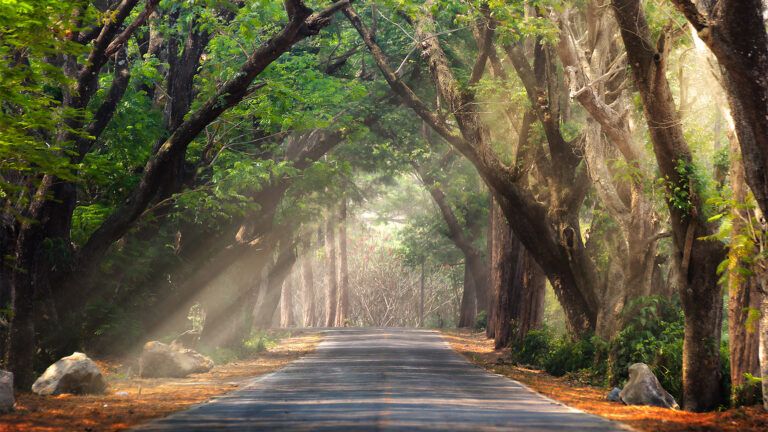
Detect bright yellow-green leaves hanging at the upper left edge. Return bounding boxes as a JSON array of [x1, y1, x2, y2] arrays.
[[0, 0, 82, 199]]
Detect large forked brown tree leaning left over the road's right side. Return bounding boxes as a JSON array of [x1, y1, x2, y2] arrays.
[[343, 2, 597, 334]]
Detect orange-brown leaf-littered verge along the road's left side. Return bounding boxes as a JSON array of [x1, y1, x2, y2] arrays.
[[0, 331, 322, 432]]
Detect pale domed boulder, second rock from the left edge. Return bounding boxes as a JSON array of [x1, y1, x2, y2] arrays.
[[32, 352, 107, 395]]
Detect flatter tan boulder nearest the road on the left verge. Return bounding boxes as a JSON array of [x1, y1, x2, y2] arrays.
[[140, 341, 213, 378]]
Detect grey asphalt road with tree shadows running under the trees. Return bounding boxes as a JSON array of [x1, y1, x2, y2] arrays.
[[138, 329, 627, 432]]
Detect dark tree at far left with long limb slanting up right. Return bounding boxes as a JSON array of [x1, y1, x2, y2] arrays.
[[3, 0, 346, 386]]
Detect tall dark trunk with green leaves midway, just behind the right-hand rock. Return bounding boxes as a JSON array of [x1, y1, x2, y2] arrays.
[[613, 0, 725, 411]]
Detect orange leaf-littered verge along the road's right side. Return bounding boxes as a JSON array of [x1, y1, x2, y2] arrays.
[[443, 330, 768, 432]]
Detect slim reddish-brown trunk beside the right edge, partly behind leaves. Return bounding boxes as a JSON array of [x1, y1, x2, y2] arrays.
[[728, 131, 762, 403]]
